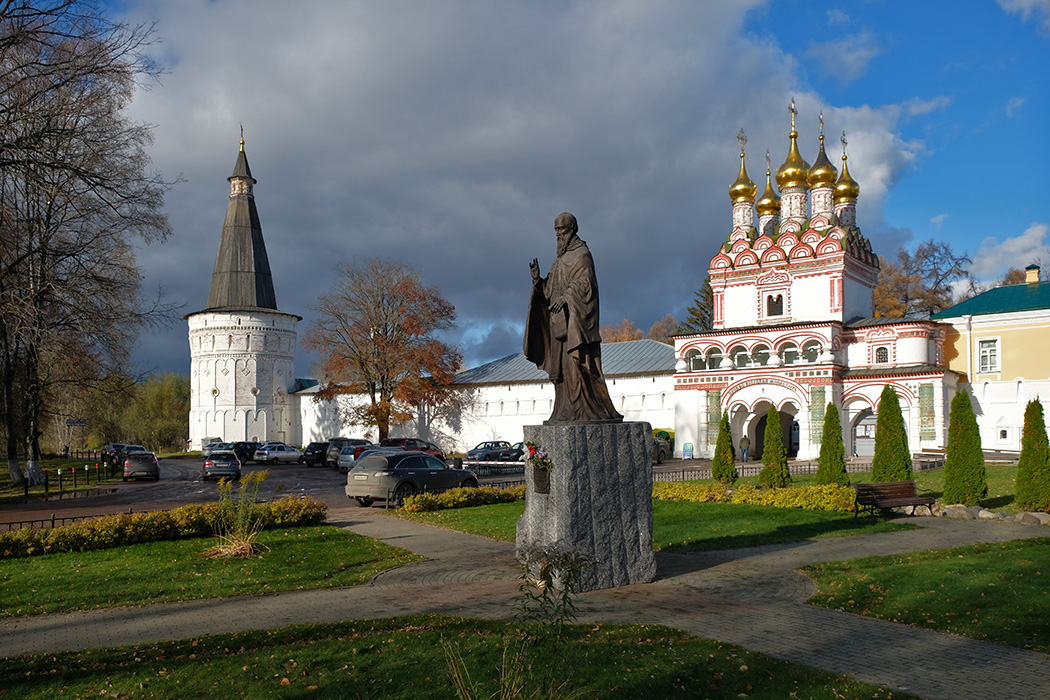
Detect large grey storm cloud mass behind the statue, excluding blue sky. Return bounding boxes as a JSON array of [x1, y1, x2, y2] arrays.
[[119, 0, 908, 375]]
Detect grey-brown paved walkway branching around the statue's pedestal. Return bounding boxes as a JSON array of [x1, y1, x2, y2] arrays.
[[0, 508, 1050, 700]]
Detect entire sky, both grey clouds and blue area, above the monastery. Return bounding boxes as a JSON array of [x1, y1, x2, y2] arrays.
[[110, 0, 1050, 376]]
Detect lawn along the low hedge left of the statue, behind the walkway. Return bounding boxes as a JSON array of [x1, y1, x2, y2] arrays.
[[0, 526, 423, 617]]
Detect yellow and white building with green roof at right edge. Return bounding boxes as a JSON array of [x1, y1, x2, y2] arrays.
[[930, 264, 1050, 450]]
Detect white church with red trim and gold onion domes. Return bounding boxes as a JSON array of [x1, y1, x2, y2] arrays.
[[674, 104, 959, 459]]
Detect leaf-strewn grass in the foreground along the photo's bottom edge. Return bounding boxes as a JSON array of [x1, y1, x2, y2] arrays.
[[0, 616, 914, 700]]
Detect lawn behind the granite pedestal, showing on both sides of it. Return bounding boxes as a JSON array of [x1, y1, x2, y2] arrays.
[[393, 501, 916, 552]]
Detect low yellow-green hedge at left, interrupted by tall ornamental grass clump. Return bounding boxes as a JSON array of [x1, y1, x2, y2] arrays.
[[0, 495, 328, 559]]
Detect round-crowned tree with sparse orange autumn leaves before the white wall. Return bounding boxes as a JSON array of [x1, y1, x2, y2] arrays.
[[302, 258, 462, 440]]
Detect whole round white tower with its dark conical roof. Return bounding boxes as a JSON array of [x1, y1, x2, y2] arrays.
[[186, 136, 302, 448]]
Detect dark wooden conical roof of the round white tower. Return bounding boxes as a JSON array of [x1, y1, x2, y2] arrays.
[[208, 139, 277, 310]]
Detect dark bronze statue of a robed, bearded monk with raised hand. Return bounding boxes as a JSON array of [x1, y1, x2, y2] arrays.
[[524, 212, 624, 425]]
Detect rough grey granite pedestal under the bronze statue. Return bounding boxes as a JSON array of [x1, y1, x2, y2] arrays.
[[517, 423, 656, 591]]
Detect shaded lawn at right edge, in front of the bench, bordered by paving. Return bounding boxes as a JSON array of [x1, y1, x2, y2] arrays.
[[802, 538, 1050, 653]]
